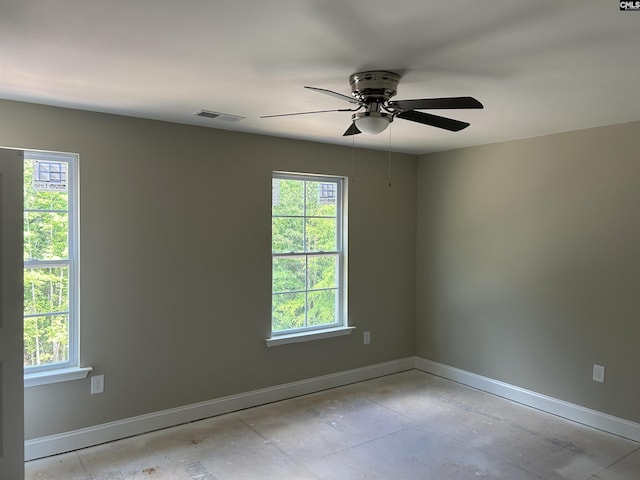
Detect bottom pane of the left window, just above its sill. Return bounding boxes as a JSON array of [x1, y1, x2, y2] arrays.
[[24, 315, 69, 367]]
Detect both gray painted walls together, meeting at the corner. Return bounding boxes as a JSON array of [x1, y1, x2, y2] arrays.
[[6, 95, 640, 439]]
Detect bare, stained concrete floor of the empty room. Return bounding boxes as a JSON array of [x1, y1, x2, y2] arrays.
[[26, 370, 640, 480]]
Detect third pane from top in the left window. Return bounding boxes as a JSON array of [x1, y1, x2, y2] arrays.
[[24, 267, 69, 315]]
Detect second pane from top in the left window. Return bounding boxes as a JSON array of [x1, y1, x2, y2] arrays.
[[24, 212, 69, 260]]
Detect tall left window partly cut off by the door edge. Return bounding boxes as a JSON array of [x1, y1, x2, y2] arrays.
[[24, 151, 78, 376]]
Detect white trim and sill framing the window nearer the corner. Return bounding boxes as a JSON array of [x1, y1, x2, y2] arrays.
[[265, 171, 356, 347]]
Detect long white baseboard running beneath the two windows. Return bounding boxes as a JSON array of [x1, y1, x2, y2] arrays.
[[24, 357, 415, 460]]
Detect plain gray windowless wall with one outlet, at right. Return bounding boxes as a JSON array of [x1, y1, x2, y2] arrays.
[[416, 123, 640, 422]]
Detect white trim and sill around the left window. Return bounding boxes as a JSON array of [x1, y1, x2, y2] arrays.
[[24, 150, 87, 388]]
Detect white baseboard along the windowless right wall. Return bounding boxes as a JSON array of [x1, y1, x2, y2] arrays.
[[415, 357, 640, 442]]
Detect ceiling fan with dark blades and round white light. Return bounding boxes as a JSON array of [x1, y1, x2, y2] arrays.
[[260, 70, 484, 136]]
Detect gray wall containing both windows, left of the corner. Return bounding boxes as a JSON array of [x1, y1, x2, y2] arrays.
[[0, 101, 417, 439]]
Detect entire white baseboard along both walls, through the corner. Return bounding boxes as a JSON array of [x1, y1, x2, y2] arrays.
[[25, 357, 640, 460]]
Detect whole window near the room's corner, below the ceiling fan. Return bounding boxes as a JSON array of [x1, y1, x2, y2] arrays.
[[271, 173, 346, 339]]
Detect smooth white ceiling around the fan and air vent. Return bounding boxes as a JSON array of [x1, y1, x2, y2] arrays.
[[0, 0, 640, 154]]
